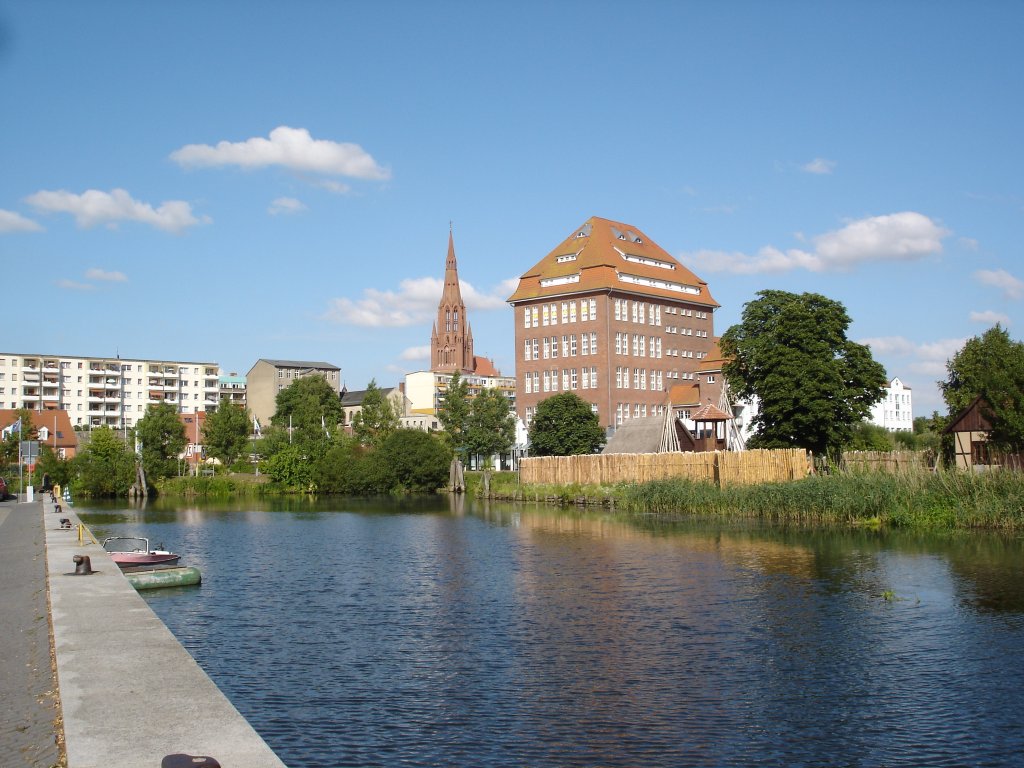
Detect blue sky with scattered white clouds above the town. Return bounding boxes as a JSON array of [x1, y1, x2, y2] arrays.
[[0, 0, 1024, 415]]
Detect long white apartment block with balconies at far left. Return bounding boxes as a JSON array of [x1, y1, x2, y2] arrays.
[[0, 352, 220, 429]]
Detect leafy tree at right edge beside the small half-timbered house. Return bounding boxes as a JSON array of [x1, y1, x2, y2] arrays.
[[939, 325, 1024, 449]]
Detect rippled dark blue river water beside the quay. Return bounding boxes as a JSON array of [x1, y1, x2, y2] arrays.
[[77, 498, 1024, 768]]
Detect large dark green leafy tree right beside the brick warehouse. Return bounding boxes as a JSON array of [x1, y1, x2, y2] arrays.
[[721, 291, 887, 454]]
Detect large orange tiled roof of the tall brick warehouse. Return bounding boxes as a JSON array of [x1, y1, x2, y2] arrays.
[[507, 216, 719, 307]]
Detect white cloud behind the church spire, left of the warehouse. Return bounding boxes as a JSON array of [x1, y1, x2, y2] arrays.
[[323, 278, 517, 328]]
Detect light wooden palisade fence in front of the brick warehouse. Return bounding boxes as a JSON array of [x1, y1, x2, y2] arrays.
[[519, 449, 811, 487]]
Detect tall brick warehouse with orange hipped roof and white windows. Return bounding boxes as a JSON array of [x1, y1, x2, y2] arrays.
[[508, 217, 719, 429]]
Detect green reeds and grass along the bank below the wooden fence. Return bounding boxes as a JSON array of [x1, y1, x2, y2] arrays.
[[467, 470, 1024, 530]]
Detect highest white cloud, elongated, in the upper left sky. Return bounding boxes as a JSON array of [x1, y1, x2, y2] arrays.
[[171, 125, 391, 179]]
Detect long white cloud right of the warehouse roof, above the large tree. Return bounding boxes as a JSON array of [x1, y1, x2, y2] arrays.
[[680, 211, 949, 274]]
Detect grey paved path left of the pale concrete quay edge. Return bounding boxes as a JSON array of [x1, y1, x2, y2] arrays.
[[0, 501, 59, 768]]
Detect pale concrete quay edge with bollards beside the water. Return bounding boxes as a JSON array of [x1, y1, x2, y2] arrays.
[[41, 500, 285, 768]]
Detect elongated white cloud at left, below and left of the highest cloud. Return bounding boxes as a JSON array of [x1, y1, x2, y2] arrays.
[[26, 189, 210, 234]]
